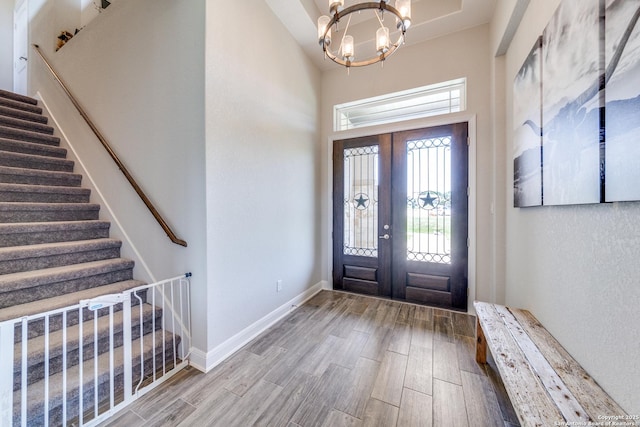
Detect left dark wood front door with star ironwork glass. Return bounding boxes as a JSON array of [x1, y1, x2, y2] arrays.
[[333, 134, 391, 297]]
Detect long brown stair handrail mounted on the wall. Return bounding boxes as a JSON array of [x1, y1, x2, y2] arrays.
[[33, 44, 187, 247]]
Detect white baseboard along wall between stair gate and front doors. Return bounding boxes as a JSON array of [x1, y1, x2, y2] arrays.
[[189, 280, 324, 372]]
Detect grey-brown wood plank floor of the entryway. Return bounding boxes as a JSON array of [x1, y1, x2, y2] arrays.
[[101, 291, 517, 427]]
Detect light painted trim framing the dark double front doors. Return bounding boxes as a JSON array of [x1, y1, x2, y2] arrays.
[[325, 112, 477, 310]]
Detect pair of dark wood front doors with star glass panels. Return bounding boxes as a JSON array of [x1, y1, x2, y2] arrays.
[[333, 123, 468, 310]]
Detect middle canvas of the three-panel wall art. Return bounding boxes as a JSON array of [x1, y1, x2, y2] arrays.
[[542, 0, 604, 205]]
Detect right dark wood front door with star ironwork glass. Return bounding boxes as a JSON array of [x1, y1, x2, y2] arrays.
[[392, 123, 469, 310]]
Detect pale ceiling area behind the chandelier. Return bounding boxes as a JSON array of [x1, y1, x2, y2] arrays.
[[266, 0, 496, 70]]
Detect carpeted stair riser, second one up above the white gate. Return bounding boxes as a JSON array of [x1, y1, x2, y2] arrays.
[[0, 246, 120, 274]]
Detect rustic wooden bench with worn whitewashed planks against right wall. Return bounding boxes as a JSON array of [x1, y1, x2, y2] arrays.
[[474, 301, 638, 427]]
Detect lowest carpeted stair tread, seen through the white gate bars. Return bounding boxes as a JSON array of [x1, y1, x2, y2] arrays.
[[13, 330, 180, 426]]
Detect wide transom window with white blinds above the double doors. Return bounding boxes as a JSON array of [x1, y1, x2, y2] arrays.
[[333, 78, 467, 132]]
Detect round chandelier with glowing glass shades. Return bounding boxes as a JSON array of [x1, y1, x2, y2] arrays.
[[318, 0, 411, 68]]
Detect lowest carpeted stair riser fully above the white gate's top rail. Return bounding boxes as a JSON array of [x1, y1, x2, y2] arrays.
[[0, 268, 133, 308]]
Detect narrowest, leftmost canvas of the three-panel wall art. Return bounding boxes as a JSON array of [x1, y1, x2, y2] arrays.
[[513, 37, 542, 207]]
